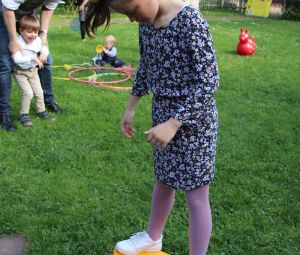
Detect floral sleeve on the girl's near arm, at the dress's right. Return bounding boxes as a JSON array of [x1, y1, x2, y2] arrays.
[[172, 13, 219, 125]]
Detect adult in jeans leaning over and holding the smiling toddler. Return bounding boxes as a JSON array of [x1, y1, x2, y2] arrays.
[[0, 0, 63, 131]]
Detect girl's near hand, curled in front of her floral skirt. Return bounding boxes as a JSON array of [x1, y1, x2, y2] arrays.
[[144, 118, 182, 148]]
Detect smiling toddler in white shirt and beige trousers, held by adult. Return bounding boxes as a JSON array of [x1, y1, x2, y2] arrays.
[[12, 16, 54, 127]]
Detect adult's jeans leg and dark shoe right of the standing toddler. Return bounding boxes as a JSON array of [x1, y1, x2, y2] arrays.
[[39, 55, 63, 113]]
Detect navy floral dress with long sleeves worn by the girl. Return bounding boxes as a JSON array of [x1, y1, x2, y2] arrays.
[[131, 6, 219, 191]]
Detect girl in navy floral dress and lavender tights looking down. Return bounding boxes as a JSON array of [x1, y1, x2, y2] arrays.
[[88, 0, 219, 255]]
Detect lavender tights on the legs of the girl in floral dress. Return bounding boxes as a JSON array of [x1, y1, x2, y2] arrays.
[[147, 182, 212, 255]]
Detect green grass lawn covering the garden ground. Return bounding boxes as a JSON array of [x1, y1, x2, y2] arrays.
[[0, 11, 300, 255]]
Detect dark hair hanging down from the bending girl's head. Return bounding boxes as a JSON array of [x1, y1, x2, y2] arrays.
[[85, 0, 112, 32]]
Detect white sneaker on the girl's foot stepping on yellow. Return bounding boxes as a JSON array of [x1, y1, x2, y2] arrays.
[[116, 232, 162, 255]]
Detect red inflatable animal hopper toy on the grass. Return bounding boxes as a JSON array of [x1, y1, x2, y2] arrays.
[[236, 28, 256, 56]]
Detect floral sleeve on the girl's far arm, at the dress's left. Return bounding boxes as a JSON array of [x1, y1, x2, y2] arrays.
[[131, 25, 149, 96]]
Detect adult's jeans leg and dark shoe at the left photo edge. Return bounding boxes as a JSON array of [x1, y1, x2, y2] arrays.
[[0, 13, 15, 131]]
